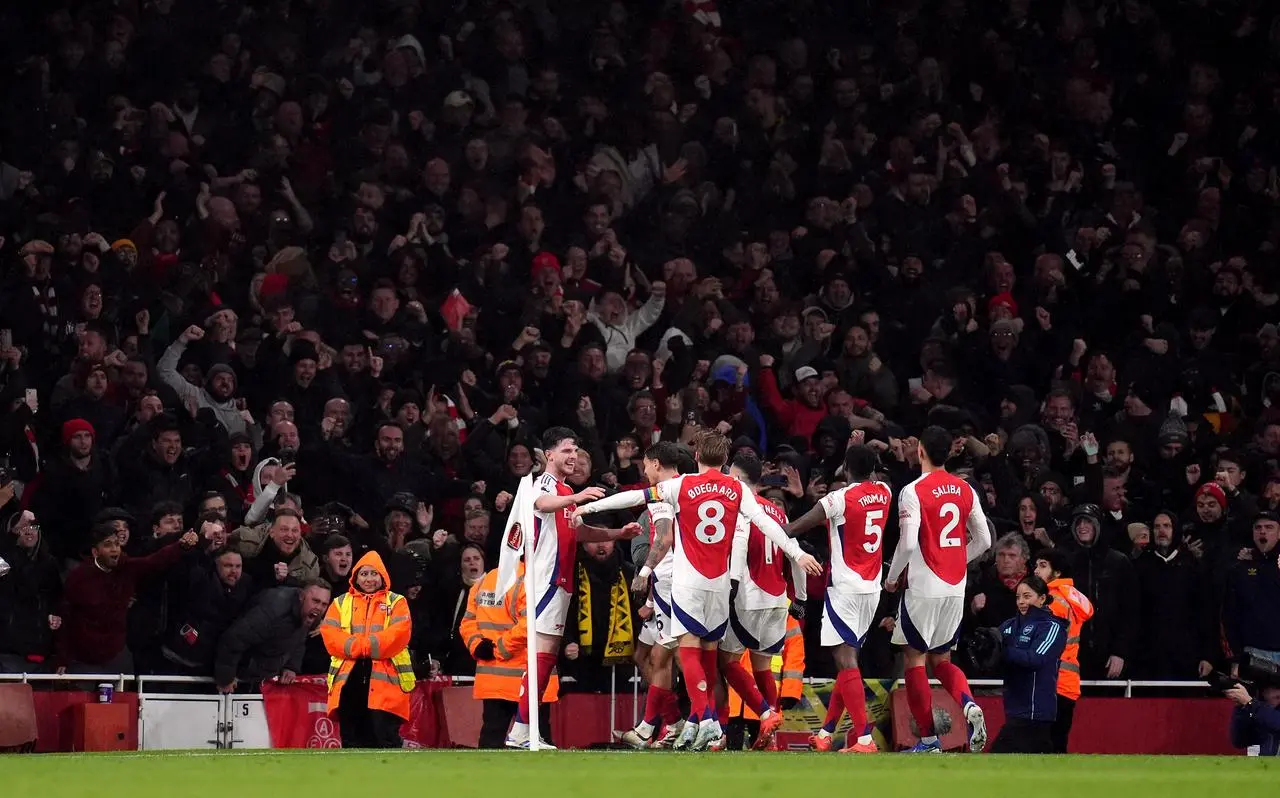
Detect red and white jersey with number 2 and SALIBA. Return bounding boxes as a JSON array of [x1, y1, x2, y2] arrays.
[[888, 469, 991, 597]]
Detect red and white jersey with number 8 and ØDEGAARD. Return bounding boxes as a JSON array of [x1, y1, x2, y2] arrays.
[[646, 471, 800, 590]]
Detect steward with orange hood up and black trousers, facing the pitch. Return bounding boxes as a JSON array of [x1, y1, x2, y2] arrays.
[[320, 552, 416, 748]]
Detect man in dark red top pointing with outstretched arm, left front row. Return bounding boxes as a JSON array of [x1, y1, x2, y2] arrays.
[[55, 524, 198, 674]]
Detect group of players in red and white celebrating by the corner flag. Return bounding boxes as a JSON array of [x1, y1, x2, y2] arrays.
[[507, 427, 991, 753]]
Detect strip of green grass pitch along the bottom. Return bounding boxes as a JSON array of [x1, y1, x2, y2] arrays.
[[0, 751, 1280, 798]]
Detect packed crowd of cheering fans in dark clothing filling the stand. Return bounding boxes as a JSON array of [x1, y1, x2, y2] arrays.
[[0, 0, 1280, 701]]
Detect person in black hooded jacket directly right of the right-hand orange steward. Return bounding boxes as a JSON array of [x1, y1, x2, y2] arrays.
[[1066, 505, 1138, 680]]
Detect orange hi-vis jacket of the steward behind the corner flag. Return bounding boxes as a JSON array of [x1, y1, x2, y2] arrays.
[[458, 566, 559, 703]]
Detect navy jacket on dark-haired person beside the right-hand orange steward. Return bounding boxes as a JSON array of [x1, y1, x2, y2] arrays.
[[1000, 607, 1066, 722]]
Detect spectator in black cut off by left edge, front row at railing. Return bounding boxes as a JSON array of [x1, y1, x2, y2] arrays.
[[0, 511, 63, 674]]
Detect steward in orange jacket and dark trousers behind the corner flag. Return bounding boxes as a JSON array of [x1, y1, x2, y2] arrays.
[[458, 566, 559, 748]]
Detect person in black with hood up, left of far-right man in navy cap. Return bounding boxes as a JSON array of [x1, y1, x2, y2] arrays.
[[1133, 511, 1217, 679]]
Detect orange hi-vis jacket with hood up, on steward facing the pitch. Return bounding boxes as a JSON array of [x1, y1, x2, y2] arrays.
[[320, 552, 417, 720]]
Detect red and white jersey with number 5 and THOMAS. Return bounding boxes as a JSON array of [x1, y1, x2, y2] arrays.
[[818, 482, 893, 593]]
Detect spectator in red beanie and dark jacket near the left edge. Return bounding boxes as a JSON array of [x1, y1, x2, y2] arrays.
[[27, 419, 119, 562]]
